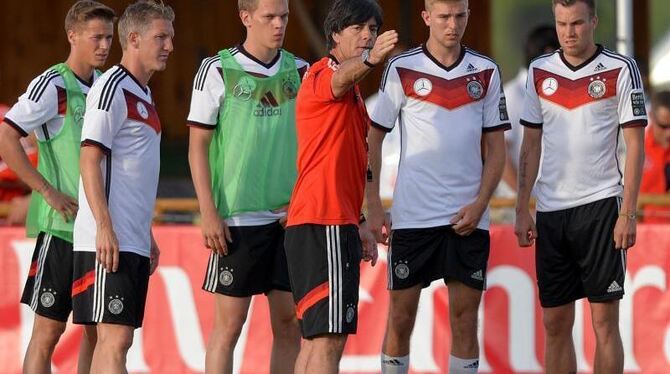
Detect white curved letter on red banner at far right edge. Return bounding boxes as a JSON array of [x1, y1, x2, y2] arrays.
[[619, 265, 670, 372]]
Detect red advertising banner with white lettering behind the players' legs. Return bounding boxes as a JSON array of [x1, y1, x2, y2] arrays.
[[0, 225, 670, 373]]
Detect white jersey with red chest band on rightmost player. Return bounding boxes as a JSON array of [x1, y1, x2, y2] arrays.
[[521, 46, 647, 212]]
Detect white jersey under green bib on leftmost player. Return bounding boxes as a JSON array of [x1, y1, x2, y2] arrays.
[[5, 68, 98, 140]]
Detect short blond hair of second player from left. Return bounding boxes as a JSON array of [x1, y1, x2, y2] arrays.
[[119, 0, 174, 50]]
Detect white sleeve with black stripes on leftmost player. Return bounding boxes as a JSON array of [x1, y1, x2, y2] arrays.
[[4, 71, 58, 136]]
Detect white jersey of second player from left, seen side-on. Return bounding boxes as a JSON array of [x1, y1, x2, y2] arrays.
[[74, 65, 161, 257]]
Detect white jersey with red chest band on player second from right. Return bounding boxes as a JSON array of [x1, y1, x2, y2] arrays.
[[371, 46, 510, 230]]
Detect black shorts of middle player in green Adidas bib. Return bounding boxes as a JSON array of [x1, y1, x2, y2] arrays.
[[202, 222, 291, 297]]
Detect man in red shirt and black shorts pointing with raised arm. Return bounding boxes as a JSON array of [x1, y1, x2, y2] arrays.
[[285, 0, 398, 373]]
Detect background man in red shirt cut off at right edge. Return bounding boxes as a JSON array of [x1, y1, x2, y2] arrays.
[[640, 91, 670, 223]]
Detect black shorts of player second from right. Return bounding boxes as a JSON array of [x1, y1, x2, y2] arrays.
[[387, 225, 491, 290]]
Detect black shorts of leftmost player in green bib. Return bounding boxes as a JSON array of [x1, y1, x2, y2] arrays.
[[21, 232, 72, 322]]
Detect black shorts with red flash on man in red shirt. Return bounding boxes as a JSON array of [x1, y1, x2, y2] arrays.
[[285, 224, 361, 338]]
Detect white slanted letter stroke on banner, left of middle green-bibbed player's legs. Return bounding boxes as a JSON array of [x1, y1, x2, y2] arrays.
[[158, 266, 205, 371]]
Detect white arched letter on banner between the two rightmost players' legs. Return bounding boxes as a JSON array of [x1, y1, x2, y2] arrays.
[[488, 265, 542, 373]]
